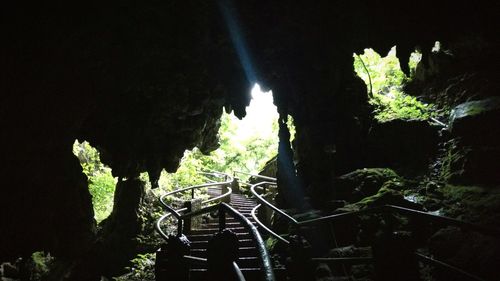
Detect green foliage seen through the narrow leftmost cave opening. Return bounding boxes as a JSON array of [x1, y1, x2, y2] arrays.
[[73, 140, 116, 223]]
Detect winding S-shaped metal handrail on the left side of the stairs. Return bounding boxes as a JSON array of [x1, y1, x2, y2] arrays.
[[155, 171, 233, 239]]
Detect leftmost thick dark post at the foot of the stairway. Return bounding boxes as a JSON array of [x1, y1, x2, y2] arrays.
[[155, 235, 191, 281]]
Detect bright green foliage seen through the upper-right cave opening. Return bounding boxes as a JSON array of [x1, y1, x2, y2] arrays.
[[354, 47, 435, 121]]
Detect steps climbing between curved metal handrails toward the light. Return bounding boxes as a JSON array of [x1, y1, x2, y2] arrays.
[[187, 188, 266, 281]]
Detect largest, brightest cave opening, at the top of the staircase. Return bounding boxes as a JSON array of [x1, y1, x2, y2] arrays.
[[158, 84, 293, 190]]
